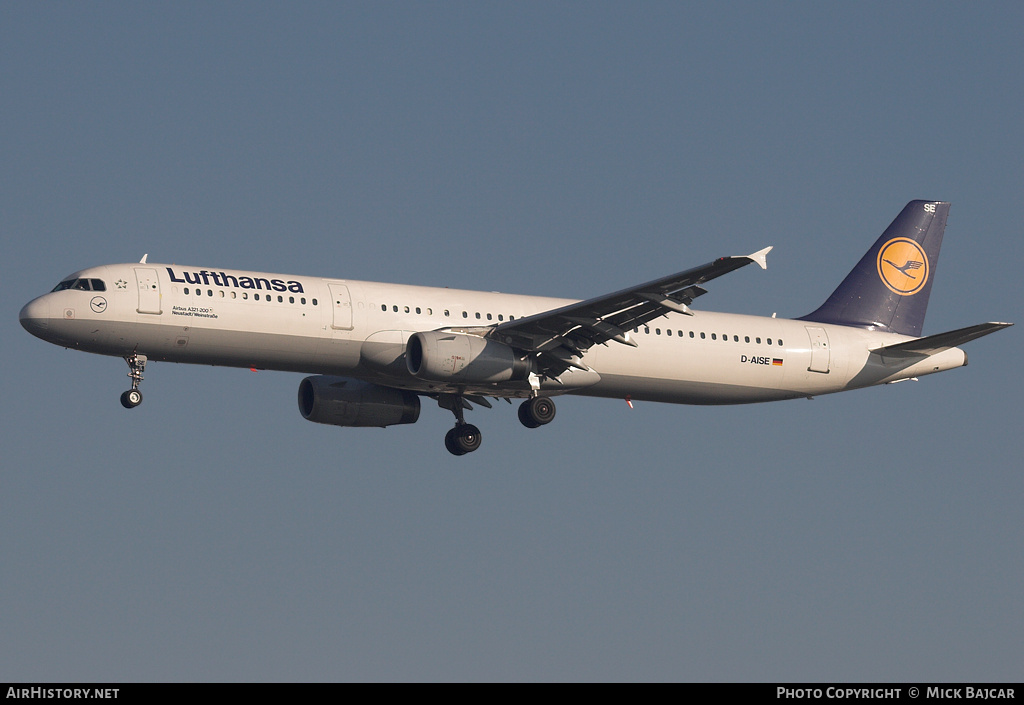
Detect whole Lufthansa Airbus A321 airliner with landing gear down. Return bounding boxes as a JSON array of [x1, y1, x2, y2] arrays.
[[19, 201, 1012, 455]]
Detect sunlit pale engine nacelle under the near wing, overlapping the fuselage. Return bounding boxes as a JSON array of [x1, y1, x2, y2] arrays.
[[406, 331, 534, 384]]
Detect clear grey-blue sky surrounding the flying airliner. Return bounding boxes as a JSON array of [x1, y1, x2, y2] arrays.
[[0, 2, 1024, 681]]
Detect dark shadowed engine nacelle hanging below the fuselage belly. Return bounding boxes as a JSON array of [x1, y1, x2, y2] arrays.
[[299, 375, 420, 428]]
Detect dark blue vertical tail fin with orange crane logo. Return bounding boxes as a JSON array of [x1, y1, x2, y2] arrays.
[[800, 201, 949, 337]]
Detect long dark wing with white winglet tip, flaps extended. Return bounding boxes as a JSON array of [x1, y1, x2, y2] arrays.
[[486, 247, 772, 377]]
